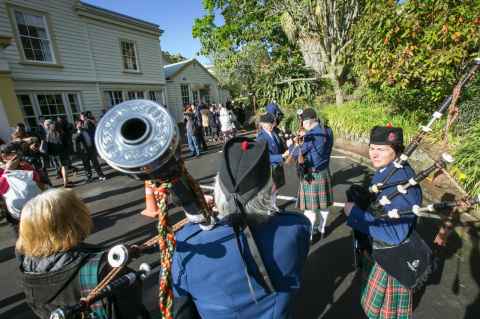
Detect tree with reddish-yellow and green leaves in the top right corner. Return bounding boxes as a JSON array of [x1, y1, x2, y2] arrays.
[[355, 0, 480, 111]]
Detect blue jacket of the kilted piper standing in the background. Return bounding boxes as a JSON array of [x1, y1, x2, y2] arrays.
[[290, 124, 333, 172]]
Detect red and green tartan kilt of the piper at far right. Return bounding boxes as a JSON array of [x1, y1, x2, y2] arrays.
[[360, 261, 413, 319]]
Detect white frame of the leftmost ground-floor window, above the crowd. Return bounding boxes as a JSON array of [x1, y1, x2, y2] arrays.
[[16, 91, 83, 128]]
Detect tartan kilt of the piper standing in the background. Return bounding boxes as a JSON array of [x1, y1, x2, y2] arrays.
[[297, 168, 333, 210]]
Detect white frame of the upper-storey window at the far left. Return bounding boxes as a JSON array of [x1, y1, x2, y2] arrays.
[[9, 6, 59, 65]]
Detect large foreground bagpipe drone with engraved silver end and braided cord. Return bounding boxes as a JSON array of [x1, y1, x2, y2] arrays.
[[49, 100, 215, 319]]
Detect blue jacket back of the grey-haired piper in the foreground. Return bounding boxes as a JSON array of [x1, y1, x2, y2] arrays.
[[172, 213, 311, 319]]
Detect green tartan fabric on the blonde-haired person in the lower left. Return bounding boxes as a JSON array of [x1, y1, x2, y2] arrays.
[[79, 253, 109, 319]]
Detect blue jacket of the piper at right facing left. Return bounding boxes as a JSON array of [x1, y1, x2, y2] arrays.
[[347, 161, 422, 245]]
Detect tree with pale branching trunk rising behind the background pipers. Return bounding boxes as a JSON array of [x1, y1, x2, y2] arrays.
[[275, 0, 363, 105]]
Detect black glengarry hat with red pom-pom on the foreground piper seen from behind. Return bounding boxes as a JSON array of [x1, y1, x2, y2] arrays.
[[219, 137, 270, 204]]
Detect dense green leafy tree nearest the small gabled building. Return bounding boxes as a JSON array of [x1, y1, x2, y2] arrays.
[[192, 0, 317, 107]]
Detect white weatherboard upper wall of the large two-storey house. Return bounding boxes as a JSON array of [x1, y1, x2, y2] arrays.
[[0, 0, 165, 125]]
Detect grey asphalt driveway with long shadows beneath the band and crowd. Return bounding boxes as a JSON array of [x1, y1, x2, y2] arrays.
[[0, 142, 480, 319]]
